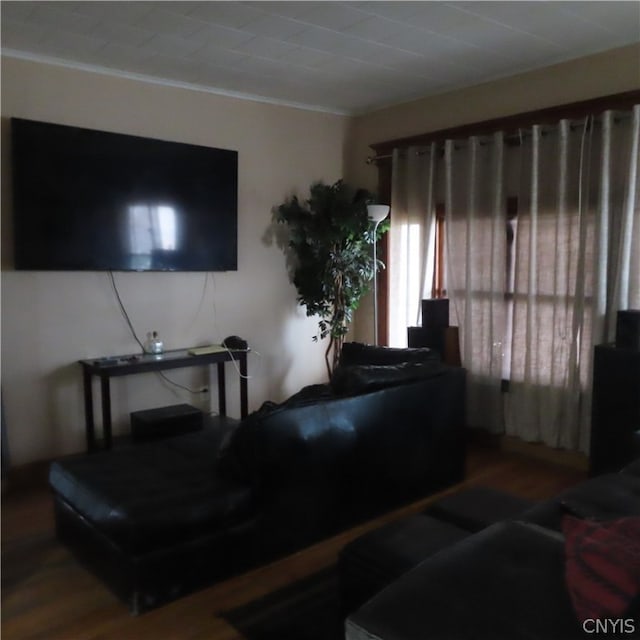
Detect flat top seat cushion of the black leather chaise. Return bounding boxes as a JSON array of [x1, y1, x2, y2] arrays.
[[49, 429, 254, 553]]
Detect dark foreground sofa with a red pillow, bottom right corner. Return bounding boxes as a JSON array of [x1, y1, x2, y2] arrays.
[[346, 460, 640, 640]]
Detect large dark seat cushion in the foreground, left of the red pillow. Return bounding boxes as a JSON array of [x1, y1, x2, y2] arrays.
[[346, 522, 585, 640]]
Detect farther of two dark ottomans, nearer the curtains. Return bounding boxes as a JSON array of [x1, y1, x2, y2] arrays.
[[424, 487, 535, 532]]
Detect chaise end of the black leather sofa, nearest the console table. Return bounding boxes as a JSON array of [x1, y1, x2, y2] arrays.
[[49, 427, 257, 614]]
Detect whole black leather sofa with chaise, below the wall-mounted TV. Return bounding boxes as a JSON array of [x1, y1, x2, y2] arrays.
[[49, 343, 465, 612]]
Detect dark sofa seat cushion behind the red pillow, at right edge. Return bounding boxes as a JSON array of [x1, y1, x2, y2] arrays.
[[521, 473, 640, 531]]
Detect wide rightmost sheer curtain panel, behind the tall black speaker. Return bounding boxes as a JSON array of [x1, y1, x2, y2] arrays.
[[506, 108, 640, 451]]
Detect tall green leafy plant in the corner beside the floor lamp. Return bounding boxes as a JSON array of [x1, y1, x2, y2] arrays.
[[274, 180, 389, 376]]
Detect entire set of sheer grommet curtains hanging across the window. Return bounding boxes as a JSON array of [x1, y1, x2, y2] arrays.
[[389, 105, 640, 451]]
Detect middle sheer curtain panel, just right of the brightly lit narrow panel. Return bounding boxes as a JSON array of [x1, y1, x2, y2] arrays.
[[445, 133, 506, 432]]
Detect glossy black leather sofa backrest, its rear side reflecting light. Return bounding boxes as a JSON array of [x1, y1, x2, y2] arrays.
[[222, 369, 465, 552]]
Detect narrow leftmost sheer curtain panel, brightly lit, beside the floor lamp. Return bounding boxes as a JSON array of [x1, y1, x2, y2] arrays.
[[388, 144, 436, 347]]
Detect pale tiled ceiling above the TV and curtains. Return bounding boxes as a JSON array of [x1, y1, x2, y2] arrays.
[[0, 0, 640, 114]]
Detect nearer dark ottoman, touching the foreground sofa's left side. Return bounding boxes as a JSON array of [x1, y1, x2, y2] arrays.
[[338, 514, 470, 615]]
